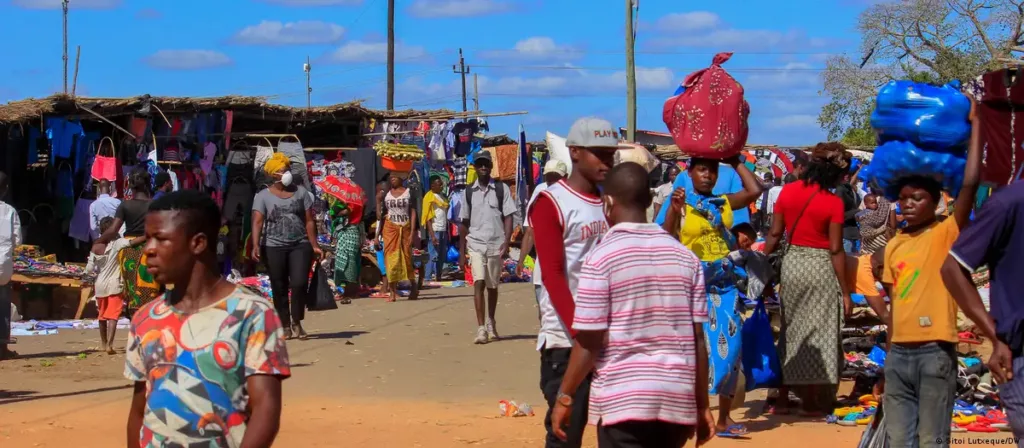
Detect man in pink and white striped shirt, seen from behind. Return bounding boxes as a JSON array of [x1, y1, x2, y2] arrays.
[[552, 163, 715, 448]]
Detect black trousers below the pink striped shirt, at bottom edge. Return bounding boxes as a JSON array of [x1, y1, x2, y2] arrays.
[[597, 421, 695, 448]]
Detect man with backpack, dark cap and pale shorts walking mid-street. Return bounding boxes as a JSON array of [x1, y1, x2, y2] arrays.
[[459, 150, 517, 344]]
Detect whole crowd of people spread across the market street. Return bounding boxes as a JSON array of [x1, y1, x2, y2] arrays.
[[0, 95, 1024, 447]]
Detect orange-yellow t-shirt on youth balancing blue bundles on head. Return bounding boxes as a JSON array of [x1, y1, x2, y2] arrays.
[[882, 218, 959, 344]]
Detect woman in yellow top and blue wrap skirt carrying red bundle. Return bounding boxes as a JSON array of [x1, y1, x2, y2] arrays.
[[664, 156, 761, 438]]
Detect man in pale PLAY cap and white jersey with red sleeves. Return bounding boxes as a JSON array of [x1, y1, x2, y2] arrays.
[[527, 118, 628, 448]]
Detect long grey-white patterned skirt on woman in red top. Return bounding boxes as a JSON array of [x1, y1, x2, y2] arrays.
[[778, 245, 843, 386]]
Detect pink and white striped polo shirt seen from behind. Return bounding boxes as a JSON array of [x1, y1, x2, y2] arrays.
[[572, 223, 708, 425]]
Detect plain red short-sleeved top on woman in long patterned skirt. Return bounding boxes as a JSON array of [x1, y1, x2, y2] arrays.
[[774, 180, 843, 249]]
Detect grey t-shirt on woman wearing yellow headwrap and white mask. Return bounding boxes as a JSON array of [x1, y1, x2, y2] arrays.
[[253, 186, 313, 248]]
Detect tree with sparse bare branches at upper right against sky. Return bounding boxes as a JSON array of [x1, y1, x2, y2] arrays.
[[818, 0, 1024, 140]]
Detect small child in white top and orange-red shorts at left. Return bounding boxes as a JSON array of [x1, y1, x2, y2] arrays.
[[85, 217, 142, 355]]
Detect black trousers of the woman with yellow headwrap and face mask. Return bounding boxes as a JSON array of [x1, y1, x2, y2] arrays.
[[263, 242, 313, 325]]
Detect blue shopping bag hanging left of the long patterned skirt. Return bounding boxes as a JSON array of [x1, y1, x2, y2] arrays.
[[741, 299, 782, 391]]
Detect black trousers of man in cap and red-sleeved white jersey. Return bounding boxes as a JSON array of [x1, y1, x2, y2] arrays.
[[541, 349, 592, 448]]
